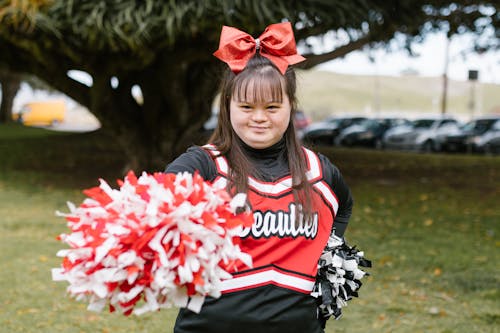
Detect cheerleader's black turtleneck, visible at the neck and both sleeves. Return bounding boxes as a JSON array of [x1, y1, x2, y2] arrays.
[[165, 139, 353, 236]]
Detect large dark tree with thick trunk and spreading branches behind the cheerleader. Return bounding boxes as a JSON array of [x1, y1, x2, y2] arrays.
[[0, 0, 499, 170]]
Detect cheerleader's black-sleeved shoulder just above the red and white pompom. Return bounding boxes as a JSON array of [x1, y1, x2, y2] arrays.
[[165, 146, 217, 180]]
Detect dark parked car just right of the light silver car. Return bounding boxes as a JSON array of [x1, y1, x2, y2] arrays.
[[442, 116, 500, 152]]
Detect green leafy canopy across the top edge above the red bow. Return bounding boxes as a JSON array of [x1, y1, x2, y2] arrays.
[[0, 0, 499, 54]]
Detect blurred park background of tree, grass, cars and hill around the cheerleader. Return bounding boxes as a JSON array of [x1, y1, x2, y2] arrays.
[[0, 0, 500, 333]]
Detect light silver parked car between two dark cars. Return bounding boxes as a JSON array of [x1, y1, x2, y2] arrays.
[[382, 117, 460, 152]]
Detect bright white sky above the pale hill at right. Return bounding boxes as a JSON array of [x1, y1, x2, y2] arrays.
[[318, 33, 500, 84]]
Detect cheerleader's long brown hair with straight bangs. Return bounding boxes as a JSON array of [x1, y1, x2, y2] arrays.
[[208, 54, 312, 219]]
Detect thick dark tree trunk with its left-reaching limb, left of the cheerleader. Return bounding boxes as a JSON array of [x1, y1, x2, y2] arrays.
[[0, 40, 223, 173]]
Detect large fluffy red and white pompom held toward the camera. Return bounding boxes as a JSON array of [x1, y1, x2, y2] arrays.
[[52, 172, 253, 315]]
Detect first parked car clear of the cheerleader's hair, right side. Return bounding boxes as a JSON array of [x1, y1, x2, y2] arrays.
[[302, 117, 367, 145]]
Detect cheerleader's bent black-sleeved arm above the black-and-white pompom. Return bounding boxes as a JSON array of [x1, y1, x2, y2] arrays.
[[318, 154, 354, 237]]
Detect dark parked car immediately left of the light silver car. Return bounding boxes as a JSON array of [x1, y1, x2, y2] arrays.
[[335, 118, 410, 149]]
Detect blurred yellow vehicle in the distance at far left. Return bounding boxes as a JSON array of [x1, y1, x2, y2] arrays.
[[13, 100, 66, 126]]
